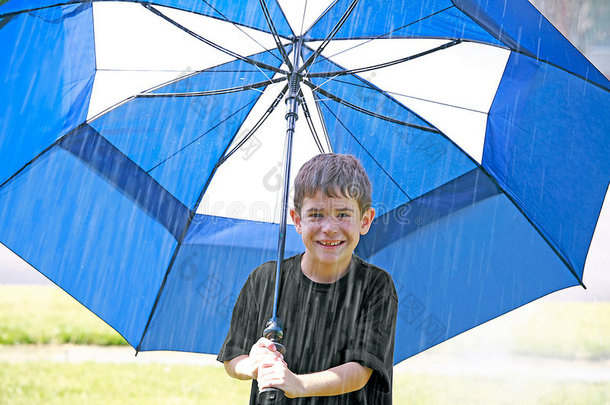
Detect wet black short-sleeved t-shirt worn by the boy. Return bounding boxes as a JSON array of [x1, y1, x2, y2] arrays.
[[218, 254, 398, 405]]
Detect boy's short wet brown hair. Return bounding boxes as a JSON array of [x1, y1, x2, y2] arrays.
[[293, 153, 371, 215]]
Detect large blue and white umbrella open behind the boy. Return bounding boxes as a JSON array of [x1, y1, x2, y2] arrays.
[[0, 0, 610, 362]]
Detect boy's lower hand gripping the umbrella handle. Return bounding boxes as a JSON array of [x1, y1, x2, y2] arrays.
[[256, 357, 305, 398]]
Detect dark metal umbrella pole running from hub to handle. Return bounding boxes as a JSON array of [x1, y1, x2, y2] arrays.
[[258, 39, 302, 404]]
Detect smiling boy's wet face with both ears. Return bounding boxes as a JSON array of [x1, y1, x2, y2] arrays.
[[290, 191, 375, 267]]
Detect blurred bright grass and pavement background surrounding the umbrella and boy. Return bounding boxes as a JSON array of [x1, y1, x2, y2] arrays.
[[0, 0, 610, 404]]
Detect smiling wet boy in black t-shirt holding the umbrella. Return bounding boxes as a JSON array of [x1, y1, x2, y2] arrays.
[[218, 153, 397, 405]]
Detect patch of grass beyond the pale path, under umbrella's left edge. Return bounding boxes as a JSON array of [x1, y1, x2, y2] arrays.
[[0, 286, 127, 346]]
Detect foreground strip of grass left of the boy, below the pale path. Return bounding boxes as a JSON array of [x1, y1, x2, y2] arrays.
[[0, 362, 250, 405]]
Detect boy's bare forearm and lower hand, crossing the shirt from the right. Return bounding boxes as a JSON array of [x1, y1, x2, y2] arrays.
[[258, 359, 373, 398]]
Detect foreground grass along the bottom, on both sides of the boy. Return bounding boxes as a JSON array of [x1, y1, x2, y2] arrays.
[[0, 362, 610, 405]]
